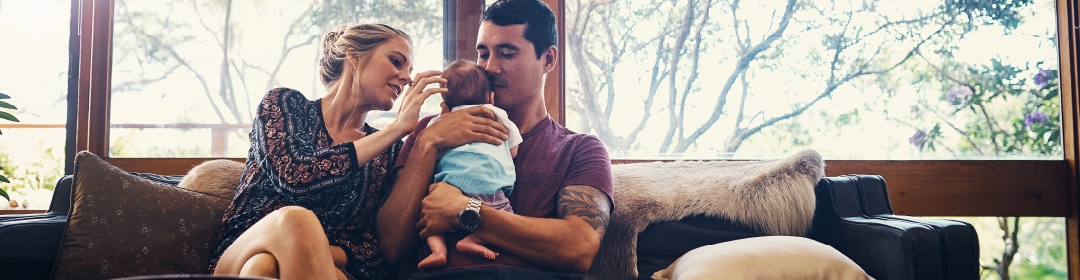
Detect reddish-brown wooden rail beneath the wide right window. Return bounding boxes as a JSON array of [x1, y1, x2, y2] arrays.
[[612, 160, 1069, 216]]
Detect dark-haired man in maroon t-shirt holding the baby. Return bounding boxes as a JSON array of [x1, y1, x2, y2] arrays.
[[378, 0, 613, 279]]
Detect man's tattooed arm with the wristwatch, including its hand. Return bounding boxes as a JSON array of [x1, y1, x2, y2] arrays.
[[420, 183, 611, 272]]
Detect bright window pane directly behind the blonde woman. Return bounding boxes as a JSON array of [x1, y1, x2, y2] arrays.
[[108, 0, 443, 158]]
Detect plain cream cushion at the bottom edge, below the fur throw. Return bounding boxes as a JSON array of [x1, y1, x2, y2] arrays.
[[652, 236, 874, 280]]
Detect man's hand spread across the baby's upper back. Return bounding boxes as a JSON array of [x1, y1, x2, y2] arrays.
[[416, 106, 509, 150]]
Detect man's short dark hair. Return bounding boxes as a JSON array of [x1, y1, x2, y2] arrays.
[[480, 0, 558, 59]]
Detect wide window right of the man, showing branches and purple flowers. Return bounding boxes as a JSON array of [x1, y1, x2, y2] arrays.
[[563, 0, 1063, 159]]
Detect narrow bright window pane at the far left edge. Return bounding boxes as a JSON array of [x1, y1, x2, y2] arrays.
[[0, 0, 71, 210]]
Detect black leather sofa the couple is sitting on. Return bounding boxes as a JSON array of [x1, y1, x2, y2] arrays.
[[0, 175, 980, 280]]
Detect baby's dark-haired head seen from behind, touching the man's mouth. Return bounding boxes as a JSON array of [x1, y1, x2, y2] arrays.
[[442, 59, 491, 108]]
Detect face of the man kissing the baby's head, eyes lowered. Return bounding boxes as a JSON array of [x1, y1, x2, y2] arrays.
[[476, 22, 554, 110]]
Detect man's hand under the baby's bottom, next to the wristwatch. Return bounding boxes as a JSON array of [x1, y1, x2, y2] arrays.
[[416, 182, 469, 238]]
